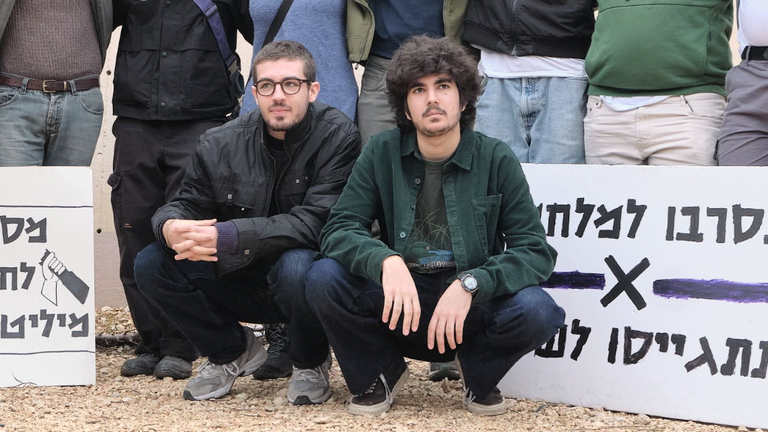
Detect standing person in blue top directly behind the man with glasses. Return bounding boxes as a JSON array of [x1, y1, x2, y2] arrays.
[[242, 0, 357, 379]]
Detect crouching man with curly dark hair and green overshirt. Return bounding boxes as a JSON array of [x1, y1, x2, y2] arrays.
[[306, 36, 564, 415]]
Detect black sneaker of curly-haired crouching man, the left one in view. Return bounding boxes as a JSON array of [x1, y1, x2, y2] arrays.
[[349, 361, 410, 415]]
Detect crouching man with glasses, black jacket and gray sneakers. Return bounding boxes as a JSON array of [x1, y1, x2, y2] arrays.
[[135, 41, 360, 405]]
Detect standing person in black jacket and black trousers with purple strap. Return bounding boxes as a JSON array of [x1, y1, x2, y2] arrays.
[[108, 0, 253, 379]]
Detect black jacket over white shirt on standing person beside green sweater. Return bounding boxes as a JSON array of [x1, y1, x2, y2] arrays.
[[462, 0, 597, 59]]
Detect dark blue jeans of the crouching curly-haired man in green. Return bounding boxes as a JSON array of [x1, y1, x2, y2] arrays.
[[306, 258, 565, 399]]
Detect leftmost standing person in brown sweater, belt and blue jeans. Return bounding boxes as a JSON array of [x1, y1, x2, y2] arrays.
[[0, 0, 112, 167]]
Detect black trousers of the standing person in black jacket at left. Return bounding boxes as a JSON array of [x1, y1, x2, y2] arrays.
[[108, 117, 224, 361]]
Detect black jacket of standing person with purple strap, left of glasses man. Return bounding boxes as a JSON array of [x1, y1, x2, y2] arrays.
[[112, 0, 253, 121]]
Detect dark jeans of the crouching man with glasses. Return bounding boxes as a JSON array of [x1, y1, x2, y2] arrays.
[[135, 243, 328, 369]]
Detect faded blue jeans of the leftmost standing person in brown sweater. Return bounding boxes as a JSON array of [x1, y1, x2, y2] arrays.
[[0, 75, 104, 167]]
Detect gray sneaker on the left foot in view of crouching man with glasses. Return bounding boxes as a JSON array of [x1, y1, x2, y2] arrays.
[[184, 329, 267, 400]]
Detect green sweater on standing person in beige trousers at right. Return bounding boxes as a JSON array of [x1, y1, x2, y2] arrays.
[[586, 1, 713, 91]]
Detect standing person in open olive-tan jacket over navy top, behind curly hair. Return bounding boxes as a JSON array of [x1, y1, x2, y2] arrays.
[[347, 0, 469, 145]]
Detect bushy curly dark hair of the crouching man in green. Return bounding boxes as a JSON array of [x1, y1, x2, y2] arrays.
[[386, 36, 480, 131]]
